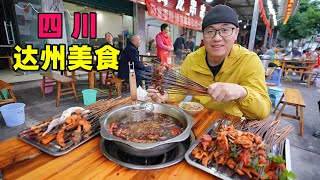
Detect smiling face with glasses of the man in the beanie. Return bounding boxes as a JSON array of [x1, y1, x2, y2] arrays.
[[203, 23, 239, 58]]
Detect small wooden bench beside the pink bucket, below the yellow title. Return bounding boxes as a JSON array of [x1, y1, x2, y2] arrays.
[[41, 72, 78, 107]]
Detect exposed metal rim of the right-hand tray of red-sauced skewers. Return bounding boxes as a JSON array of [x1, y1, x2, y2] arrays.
[[185, 122, 291, 180]]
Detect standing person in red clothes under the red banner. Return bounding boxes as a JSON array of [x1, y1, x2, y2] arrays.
[[156, 23, 174, 65]]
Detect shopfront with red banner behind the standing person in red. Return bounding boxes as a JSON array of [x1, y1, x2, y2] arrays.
[[132, 0, 211, 54]]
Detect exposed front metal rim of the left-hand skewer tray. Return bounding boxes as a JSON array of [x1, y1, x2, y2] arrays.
[[18, 128, 100, 156]]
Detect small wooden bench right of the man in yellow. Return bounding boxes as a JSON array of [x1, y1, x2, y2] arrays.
[[273, 88, 306, 136]]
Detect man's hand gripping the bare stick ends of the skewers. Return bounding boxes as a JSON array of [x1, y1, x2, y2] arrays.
[[207, 82, 248, 102]]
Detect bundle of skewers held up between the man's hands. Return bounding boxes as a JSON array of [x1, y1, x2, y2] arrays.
[[142, 60, 207, 96]]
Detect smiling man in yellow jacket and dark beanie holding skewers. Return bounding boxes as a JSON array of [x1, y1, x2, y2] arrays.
[[148, 5, 271, 119]]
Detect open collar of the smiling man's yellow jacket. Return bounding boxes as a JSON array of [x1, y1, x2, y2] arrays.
[[192, 44, 241, 76]]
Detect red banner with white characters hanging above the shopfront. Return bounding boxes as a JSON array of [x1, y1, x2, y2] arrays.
[[146, 0, 211, 30]]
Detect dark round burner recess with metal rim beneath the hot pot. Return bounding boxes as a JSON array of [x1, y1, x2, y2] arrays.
[[100, 131, 196, 170]]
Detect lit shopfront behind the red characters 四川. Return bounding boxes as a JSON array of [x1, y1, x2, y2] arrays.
[[0, 0, 133, 82]]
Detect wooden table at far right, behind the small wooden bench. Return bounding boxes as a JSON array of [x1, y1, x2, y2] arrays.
[[280, 60, 316, 87]]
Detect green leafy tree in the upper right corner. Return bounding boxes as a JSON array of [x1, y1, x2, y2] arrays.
[[279, 0, 320, 45]]
